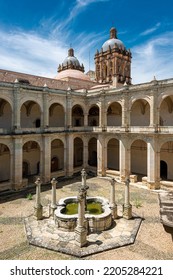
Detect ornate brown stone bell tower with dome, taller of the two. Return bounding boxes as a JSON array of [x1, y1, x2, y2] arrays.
[[94, 27, 132, 87]]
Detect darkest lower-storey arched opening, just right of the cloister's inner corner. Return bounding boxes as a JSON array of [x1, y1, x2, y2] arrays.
[[88, 137, 97, 167]]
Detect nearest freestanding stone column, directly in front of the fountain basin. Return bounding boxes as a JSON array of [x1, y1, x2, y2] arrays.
[[75, 188, 87, 247]]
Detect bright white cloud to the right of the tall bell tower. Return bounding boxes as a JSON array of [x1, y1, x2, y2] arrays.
[[131, 32, 173, 84]]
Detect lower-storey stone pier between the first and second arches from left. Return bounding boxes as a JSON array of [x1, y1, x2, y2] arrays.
[[11, 136, 23, 190]]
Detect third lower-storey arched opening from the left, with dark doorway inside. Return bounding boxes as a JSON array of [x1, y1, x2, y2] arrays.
[[51, 139, 64, 172]]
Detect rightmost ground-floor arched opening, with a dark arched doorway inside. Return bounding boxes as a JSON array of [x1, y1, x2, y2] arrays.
[[160, 141, 173, 181]]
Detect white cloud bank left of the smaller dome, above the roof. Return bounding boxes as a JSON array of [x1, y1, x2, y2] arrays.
[[0, 31, 67, 77]]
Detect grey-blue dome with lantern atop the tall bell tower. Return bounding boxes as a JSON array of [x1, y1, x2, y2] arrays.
[[102, 28, 125, 52]]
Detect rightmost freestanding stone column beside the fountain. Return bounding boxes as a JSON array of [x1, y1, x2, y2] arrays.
[[123, 178, 132, 220]]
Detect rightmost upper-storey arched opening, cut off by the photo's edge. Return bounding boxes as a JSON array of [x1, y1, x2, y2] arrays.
[[160, 95, 173, 126]]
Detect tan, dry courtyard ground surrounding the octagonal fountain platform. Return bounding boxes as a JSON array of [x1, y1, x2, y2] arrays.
[[0, 176, 173, 260]]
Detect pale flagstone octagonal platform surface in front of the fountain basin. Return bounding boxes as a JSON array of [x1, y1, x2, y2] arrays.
[[25, 207, 142, 257]]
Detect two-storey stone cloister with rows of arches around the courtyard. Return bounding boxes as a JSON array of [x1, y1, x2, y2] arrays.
[[0, 77, 173, 190]]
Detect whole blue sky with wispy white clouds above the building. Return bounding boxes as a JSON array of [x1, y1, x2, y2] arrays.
[[0, 0, 173, 84]]
